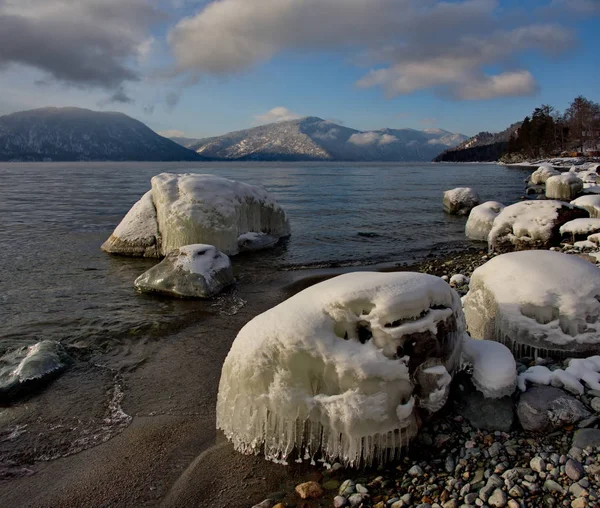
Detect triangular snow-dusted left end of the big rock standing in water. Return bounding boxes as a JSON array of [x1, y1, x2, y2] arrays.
[[101, 191, 160, 258]]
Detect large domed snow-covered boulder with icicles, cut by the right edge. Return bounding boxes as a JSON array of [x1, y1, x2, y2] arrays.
[[463, 251, 600, 357]]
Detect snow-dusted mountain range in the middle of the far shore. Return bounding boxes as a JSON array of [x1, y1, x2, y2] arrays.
[[189, 117, 466, 161]]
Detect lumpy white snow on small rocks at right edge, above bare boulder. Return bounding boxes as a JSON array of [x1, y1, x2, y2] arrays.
[[518, 356, 600, 395]]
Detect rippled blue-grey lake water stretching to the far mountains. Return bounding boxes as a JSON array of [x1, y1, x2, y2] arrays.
[[0, 163, 530, 353]]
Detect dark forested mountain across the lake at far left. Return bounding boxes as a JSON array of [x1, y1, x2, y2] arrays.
[[0, 108, 205, 161]]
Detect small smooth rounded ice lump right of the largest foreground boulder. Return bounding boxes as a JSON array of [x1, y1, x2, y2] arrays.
[[462, 334, 517, 399]]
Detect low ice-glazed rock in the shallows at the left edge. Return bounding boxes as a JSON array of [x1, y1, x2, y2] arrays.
[[0, 340, 68, 402]]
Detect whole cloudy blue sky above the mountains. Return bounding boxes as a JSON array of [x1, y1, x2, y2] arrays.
[[0, 0, 600, 137]]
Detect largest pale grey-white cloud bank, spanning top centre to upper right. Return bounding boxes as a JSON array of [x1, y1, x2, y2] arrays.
[[168, 0, 576, 99]]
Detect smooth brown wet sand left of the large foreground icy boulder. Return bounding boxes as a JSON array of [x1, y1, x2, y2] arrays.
[[0, 250, 482, 507]]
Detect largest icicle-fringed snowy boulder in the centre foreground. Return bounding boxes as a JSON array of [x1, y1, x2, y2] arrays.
[[217, 272, 464, 465]]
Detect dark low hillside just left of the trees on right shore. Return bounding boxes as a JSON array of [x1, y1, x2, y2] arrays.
[[435, 122, 521, 162]]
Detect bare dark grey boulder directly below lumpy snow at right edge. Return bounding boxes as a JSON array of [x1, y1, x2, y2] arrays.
[[517, 386, 591, 433]]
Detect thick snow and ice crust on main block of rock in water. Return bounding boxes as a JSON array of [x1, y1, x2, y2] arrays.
[[152, 173, 290, 255]]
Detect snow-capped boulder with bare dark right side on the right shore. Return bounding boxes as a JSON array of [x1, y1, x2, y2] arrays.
[[488, 200, 588, 252]]
